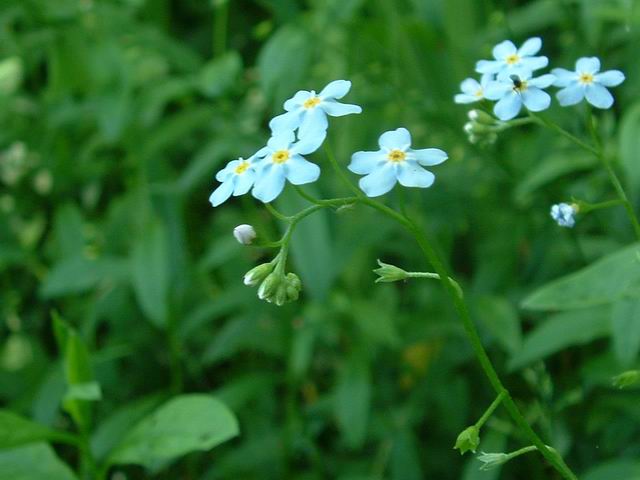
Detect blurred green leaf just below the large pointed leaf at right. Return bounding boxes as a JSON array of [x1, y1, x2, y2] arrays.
[[509, 307, 611, 370]]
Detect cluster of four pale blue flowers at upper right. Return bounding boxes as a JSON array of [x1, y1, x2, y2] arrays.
[[454, 37, 624, 121]]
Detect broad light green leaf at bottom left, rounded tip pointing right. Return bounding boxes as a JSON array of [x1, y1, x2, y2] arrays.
[[109, 395, 238, 468]]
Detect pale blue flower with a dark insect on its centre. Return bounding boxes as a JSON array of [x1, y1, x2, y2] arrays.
[[485, 70, 556, 120]]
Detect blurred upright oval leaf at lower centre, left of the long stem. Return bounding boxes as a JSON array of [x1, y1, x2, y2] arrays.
[[334, 355, 371, 449]]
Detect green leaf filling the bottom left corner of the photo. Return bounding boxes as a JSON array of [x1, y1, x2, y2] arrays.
[[0, 443, 76, 480]]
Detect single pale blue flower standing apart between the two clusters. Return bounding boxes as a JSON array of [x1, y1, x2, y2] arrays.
[[348, 128, 448, 197]]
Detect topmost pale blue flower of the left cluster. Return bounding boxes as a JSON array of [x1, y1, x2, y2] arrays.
[[269, 80, 362, 137]]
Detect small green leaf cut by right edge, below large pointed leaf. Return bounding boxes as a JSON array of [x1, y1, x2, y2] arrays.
[[611, 298, 640, 366]]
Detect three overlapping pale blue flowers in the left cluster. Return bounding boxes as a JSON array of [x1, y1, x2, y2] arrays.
[[209, 80, 362, 207]]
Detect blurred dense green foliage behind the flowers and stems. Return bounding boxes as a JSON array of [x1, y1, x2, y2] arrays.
[[0, 0, 640, 480]]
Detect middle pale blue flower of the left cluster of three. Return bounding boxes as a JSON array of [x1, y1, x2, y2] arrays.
[[251, 130, 327, 203]]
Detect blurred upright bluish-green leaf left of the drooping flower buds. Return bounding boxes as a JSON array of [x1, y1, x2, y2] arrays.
[[131, 221, 169, 328]]
